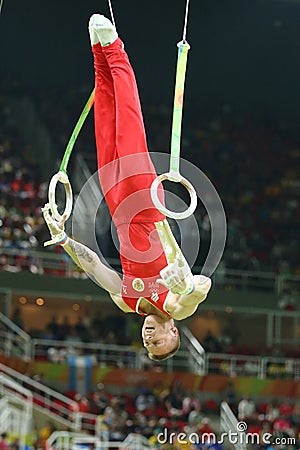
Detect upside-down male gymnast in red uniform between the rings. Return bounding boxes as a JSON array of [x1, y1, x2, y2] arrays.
[[43, 14, 211, 361]]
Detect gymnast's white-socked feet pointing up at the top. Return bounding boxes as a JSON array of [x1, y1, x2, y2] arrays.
[[89, 14, 118, 47]]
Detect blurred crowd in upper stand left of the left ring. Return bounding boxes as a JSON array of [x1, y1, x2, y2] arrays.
[[0, 94, 47, 271]]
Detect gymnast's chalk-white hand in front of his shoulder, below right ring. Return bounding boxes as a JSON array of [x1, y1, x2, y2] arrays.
[[157, 254, 194, 295]]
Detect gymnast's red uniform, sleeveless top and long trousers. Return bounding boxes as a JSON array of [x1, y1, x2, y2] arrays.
[[92, 38, 168, 316]]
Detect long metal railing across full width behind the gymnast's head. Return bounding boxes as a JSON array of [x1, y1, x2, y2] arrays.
[[0, 313, 300, 380]]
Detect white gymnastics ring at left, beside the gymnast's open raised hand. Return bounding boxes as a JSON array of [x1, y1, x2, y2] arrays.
[[48, 170, 73, 222]]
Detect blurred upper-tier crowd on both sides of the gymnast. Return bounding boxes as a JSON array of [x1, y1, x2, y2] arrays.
[[0, 85, 300, 274]]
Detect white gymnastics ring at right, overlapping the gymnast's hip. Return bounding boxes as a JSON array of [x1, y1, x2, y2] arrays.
[[150, 172, 197, 220]]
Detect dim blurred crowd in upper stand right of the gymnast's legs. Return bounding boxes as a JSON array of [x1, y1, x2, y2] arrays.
[[146, 106, 300, 273]]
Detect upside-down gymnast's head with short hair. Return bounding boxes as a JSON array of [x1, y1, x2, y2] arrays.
[[142, 314, 180, 361]]
